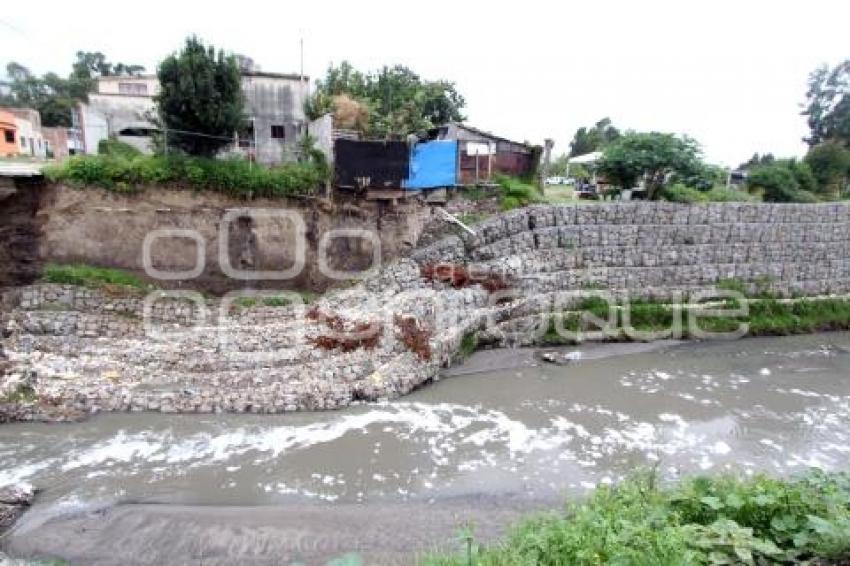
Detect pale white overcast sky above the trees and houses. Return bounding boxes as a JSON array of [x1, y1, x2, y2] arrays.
[[0, 0, 850, 165]]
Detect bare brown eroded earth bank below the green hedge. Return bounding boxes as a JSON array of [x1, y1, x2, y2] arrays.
[[40, 186, 438, 294]]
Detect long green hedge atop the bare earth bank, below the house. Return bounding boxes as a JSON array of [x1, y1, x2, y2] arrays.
[[45, 154, 328, 197]]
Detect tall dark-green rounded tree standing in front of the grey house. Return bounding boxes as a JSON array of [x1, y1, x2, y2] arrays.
[[155, 36, 244, 156]]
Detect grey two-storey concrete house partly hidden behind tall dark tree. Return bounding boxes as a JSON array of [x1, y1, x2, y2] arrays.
[[77, 71, 310, 165]]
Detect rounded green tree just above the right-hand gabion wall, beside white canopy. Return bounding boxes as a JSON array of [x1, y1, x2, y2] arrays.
[[596, 132, 702, 200]]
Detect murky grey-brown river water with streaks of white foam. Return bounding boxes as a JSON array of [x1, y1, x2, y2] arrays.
[[0, 333, 850, 564]]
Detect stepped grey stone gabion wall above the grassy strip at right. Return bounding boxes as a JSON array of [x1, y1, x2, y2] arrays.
[[413, 203, 850, 294]]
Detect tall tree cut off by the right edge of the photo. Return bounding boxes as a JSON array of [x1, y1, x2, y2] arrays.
[[803, 59, 850, 147]]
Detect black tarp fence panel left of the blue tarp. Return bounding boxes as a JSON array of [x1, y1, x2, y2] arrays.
[[334, 139, 410, 189]]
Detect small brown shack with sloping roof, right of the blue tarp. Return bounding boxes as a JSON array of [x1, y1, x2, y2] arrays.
[[429, 122, 540, 185]]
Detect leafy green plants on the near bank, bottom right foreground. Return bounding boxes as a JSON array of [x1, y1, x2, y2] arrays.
[[423, 471, 850, 566]]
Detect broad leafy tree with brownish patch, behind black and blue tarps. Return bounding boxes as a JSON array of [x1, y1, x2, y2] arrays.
[[305, 61, 465, 138]]
